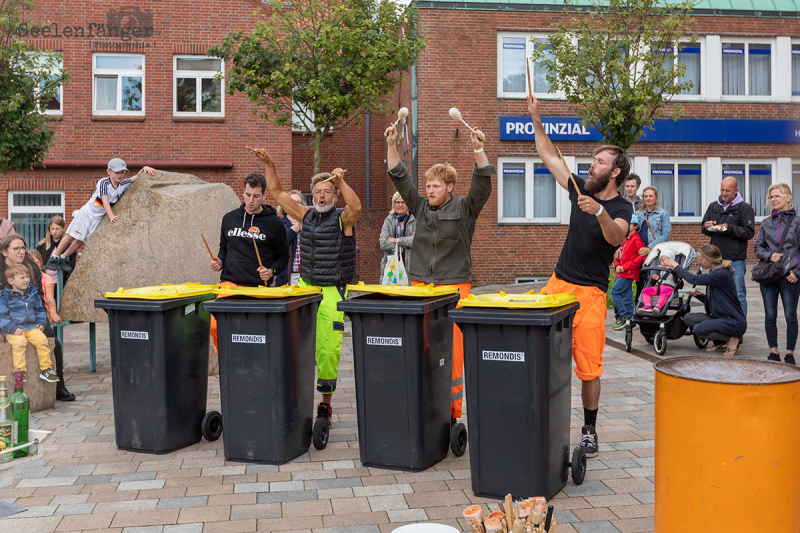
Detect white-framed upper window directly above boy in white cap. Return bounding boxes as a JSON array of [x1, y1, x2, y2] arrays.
[[92, 54, 144, 115]]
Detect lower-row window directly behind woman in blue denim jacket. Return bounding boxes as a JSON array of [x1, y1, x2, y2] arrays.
[[650, 162, 703, 219]]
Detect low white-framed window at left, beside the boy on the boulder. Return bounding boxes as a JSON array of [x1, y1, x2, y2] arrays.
[[8, 191, 64, 248]]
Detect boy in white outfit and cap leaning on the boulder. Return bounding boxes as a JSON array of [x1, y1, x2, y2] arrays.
[[47, 159, 156, 272]]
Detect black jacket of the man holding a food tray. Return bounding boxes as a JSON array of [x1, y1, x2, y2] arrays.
[[700, 197, 756, 261]]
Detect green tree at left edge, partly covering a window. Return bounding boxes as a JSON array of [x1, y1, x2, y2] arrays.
[[0, 0, 69, 174]]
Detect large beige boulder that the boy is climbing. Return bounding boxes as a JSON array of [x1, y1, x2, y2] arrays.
[[61, 171, 241, 324]]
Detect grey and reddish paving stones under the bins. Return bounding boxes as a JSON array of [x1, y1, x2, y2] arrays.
[[0, 278, 782, 533]]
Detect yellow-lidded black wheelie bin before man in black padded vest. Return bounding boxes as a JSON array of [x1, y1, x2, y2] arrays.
[[204, 286, 322, 464]]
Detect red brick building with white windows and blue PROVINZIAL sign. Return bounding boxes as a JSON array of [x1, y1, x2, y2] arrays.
[[6, 0, 800, 285]]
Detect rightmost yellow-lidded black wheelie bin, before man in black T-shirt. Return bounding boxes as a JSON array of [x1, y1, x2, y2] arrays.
[[450, 292, 586, 500]]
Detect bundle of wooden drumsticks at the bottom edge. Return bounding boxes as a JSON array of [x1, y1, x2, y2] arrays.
[[464, 494, 557, 533]]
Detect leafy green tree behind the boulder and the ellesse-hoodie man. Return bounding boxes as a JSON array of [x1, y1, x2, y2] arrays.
[[208, 0, 424, 173]]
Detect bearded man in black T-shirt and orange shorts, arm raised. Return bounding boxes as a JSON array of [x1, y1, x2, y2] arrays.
[[528, 96, 633, 457]]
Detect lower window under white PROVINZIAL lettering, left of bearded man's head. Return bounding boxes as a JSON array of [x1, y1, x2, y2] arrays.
[[499, 158, 560, 222]]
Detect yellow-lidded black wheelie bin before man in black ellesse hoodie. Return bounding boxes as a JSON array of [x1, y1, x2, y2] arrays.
[[94, 283, 219, 453]]
